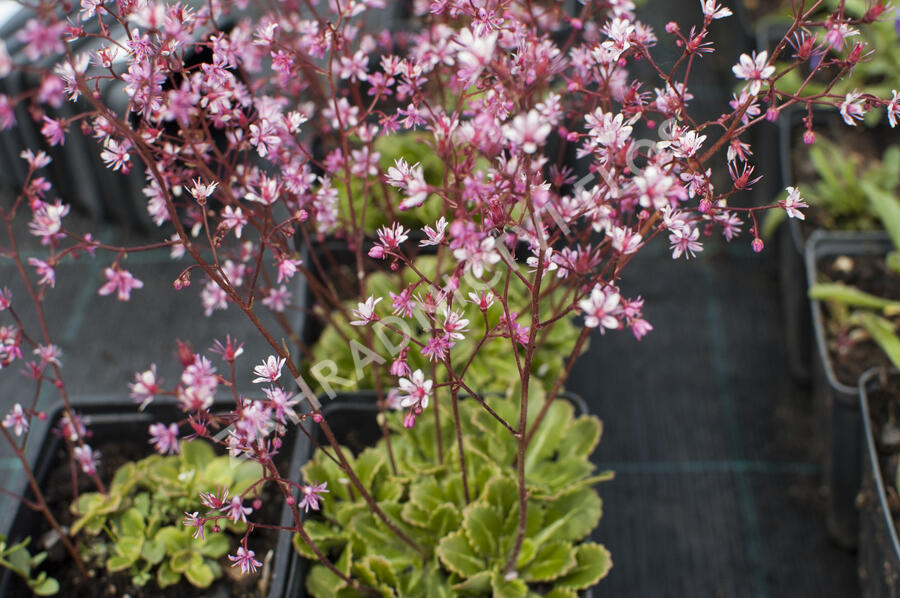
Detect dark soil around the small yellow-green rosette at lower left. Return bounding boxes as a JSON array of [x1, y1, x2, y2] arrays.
[[31, 441, 287, 598]]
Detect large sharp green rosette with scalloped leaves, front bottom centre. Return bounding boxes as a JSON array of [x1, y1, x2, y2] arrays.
[[294, 387, 612, 598]]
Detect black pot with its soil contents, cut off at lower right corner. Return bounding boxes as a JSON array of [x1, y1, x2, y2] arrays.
[[859, 368, 900, 598]]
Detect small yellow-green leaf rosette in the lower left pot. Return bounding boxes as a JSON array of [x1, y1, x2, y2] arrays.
[[71, 440, 262, 588]]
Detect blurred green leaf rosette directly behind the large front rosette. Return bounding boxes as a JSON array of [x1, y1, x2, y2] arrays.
[[309, 255, 587, 394]]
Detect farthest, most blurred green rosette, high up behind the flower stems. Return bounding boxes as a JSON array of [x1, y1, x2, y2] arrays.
[[334, 132, 444, 235]]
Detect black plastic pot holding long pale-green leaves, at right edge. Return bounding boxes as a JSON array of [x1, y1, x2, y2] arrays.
[[806, 231, 892, 548]]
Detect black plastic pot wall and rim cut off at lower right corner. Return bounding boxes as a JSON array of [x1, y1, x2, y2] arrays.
[[858, 368, 900, 598]]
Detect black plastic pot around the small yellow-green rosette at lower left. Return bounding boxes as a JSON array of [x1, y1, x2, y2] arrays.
[[0, 396, 309, 598]]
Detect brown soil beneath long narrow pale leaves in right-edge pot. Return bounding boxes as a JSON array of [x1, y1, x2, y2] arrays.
[[818, 255, 900, 386]]
